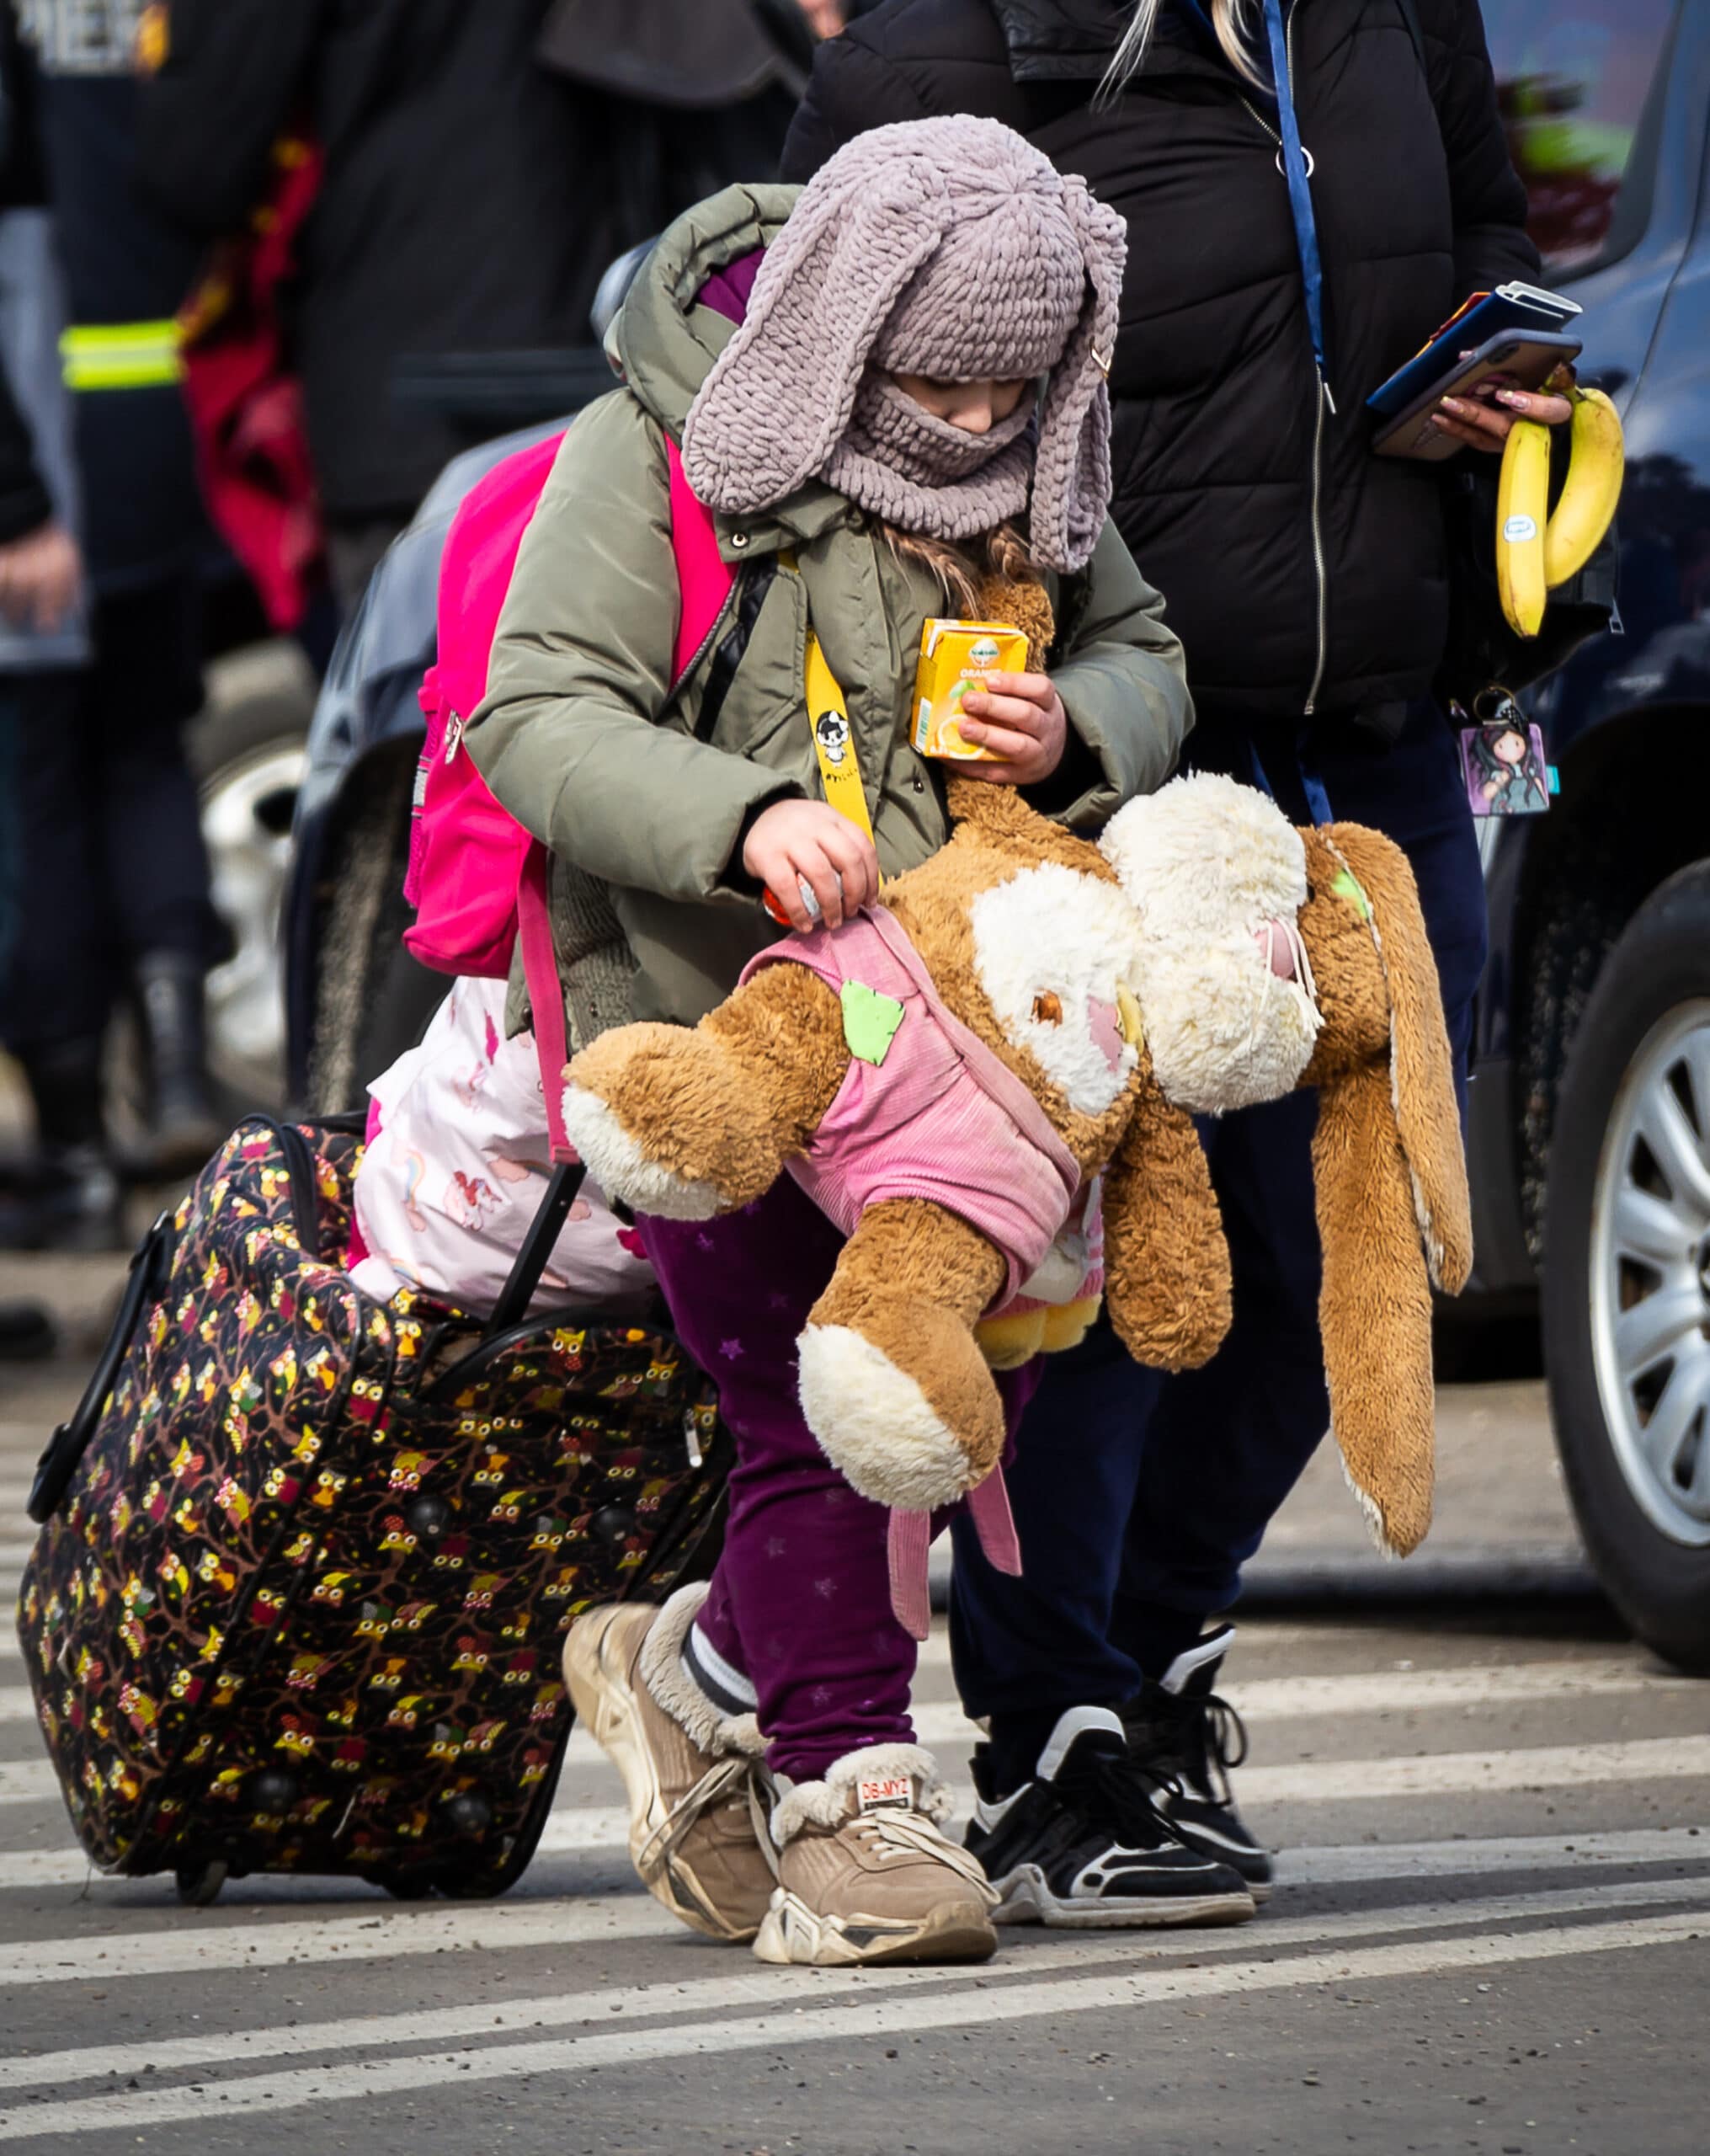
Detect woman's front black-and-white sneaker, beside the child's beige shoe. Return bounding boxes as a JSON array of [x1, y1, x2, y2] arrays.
[[968, 1708, 1253, 1929]]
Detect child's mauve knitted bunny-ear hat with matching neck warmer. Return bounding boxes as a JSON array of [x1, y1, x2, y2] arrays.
[[684, 115, 1126, 571]]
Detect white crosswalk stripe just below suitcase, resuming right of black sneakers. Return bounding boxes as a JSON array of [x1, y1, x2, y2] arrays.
[[0, 1826, 1710, 1988]]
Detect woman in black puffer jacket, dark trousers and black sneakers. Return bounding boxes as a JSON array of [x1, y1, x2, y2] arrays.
[[785, 0, 1568, 1924]]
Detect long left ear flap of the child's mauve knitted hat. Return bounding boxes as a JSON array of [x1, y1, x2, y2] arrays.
[[684, 168, 951, 509]]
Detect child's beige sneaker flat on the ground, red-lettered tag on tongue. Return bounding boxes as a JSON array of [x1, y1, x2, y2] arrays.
[[754, 1744, 999, 1968]]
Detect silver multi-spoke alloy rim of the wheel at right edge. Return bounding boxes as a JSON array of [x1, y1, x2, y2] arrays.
[[1590, 998, 1710, 1548]]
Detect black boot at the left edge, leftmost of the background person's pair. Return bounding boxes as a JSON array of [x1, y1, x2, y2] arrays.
[[0, 1039, 127, 1251]]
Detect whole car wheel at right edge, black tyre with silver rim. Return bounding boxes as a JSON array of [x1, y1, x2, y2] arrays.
[[1544, 865, 1710, 1675]]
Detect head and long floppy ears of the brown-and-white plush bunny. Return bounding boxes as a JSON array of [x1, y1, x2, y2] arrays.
[[1104, 776, 1473, 1556]]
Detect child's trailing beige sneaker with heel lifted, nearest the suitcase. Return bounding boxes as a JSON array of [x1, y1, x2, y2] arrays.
[[565, 1585, 776, 1938]]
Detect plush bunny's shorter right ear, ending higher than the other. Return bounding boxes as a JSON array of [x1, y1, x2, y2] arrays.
[[1326, 824, 1473, 1296]]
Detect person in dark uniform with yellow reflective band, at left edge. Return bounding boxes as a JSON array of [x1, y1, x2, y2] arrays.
[[0, 0, 224, 1248]]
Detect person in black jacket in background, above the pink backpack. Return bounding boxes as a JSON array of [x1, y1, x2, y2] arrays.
[[140, 0, 841, 612]]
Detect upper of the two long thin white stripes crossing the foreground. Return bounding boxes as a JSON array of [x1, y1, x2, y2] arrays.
[[0, 1878, 1710, 2089]]
